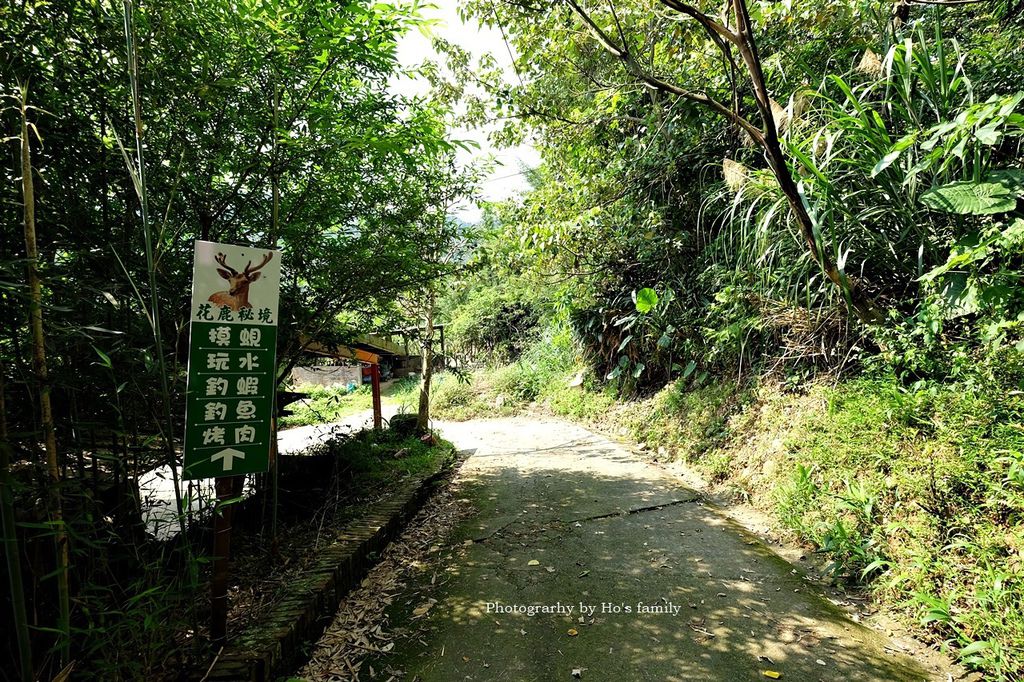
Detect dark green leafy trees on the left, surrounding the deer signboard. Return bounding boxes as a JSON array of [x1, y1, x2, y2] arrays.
[[0, 0, 472, 679]]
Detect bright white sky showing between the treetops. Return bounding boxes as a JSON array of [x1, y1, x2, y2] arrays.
[[392, 0, 541, 222]]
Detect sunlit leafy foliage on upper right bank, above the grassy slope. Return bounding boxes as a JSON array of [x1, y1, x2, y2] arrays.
[[456, 1, 1024, 386]]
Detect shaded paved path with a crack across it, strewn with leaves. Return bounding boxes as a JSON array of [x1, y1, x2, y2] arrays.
[[368, 418, 944, 682]]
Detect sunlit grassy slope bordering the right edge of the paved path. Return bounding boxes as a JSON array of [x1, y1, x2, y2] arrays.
[[434, 357, 1024, 679]]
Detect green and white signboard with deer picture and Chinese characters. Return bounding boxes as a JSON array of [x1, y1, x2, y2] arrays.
[[184, 241, 281, 478]]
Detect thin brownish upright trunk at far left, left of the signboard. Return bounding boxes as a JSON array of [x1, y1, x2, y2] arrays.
[[20, 87, 71, 666]]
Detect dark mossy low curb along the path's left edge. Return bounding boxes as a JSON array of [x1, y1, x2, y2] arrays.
[[205, 456, 450, 682]]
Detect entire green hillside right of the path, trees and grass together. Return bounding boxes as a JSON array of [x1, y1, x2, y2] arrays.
[[433, 0, 1024, 680]]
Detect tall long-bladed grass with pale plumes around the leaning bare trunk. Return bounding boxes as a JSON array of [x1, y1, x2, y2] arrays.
[[701, 25, 974, 315]]
